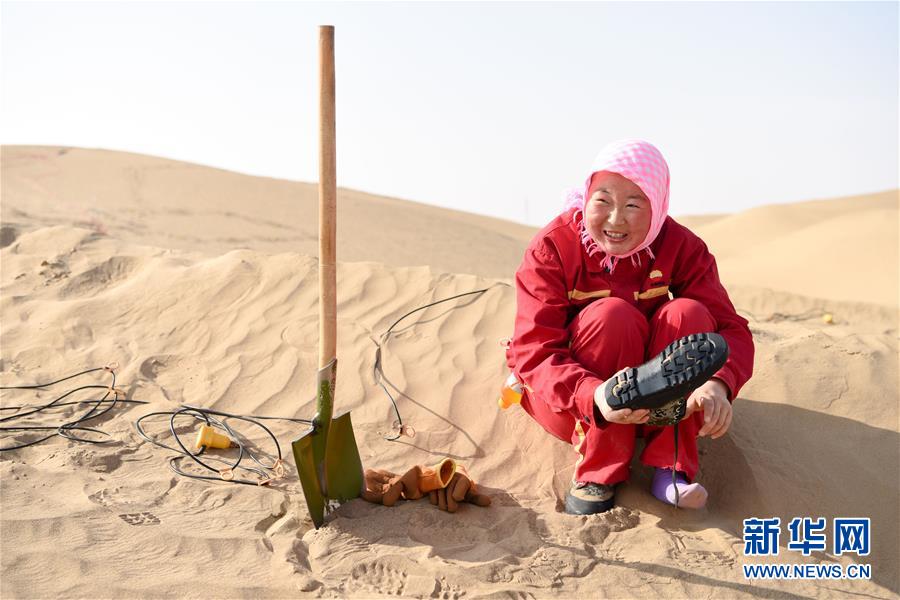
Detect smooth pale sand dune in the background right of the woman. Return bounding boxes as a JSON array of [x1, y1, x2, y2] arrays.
[[694, 190, 900, 306]]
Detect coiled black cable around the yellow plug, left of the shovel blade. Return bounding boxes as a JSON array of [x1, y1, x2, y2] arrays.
[[134, 404, 312, 486]]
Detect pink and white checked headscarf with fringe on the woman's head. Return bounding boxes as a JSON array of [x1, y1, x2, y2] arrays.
[[565, 139, 669, 271]]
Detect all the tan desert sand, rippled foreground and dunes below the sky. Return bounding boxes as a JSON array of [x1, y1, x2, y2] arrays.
[[0, 146, 900, 598]]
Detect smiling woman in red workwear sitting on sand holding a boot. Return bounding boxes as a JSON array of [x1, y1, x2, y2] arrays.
[[507, 140, 754, 514]]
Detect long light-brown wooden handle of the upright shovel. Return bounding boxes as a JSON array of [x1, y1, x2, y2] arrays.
[[319, 25, 337, 369]]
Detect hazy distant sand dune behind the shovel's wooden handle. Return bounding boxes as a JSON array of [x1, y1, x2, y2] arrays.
[[0, 146, 535, 277]]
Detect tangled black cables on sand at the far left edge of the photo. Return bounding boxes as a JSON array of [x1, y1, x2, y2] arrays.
[[0, 363, 146, 452]]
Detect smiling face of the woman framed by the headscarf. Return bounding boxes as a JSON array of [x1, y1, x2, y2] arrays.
[[584, 171, 652, 255]]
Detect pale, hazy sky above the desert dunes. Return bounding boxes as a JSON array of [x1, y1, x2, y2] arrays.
[[0, 2, 900, 225]]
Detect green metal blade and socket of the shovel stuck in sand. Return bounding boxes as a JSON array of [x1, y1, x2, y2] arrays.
[[291, 360, 364, 529]]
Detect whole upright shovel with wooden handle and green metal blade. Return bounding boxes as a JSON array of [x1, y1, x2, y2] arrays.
[[291, 25, 364, 529]]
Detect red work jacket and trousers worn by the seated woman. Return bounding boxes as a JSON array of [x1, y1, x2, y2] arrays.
[[507, 209, 754, 484]]
